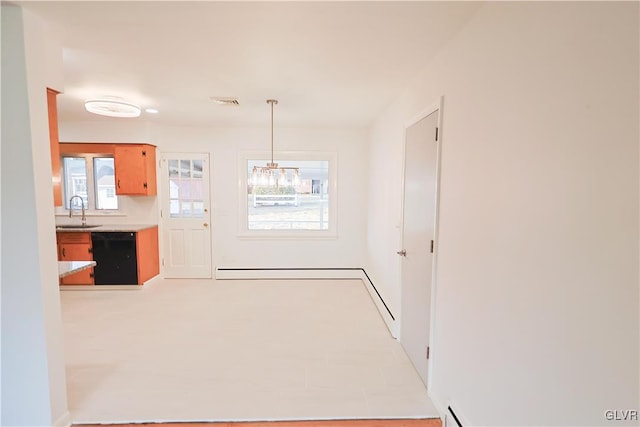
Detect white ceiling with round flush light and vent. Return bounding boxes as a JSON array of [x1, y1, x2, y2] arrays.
[[21, 1, 480, 126]]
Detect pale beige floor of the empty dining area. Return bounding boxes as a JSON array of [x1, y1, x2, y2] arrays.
[[61, 280, 437, 423]]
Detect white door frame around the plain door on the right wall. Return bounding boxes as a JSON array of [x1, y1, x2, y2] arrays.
[[398, 96, 444, 390]]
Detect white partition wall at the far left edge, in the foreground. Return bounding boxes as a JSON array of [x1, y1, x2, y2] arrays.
[[1, 4, 69, 426]]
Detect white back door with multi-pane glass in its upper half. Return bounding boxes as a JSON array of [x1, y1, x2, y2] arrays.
[[160, 153, 212, 278]]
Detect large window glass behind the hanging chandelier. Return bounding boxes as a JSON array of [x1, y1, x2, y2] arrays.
[[247, 160, 329, 230]]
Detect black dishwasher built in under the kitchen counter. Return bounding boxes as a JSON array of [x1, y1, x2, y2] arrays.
[[91, 231, 138, 285]]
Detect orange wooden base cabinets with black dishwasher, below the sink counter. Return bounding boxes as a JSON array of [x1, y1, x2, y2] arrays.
[[58, 227, 160, 285]]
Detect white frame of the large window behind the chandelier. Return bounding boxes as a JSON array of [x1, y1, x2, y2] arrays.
[[238, 151, 338, 239]]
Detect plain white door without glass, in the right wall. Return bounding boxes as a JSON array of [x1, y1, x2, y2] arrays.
[[398, 111, 438, 385]]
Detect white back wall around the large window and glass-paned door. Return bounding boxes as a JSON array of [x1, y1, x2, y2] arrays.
[[60, 121, 368, 268]]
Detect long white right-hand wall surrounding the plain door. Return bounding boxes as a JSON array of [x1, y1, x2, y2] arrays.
[[368, 2, 640, 425]]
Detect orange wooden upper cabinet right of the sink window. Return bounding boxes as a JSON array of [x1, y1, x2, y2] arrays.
[[113, 144, 157, 196]]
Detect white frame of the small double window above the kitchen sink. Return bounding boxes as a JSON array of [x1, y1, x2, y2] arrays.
[[56, 153, 122, 216]]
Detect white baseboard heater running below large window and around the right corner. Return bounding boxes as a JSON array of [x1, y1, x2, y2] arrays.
[[216, 268, 398, 338]]
